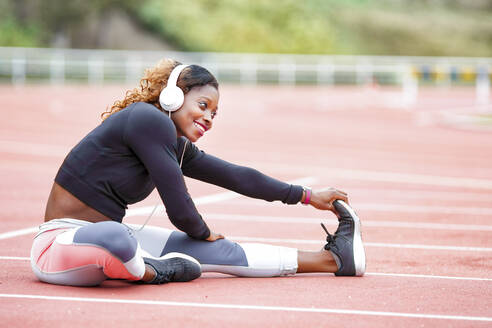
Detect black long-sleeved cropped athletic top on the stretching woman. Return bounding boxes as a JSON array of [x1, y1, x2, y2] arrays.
[[55, 102, 302, 239]]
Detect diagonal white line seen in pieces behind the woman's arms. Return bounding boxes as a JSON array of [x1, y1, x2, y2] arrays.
[[125, 177, 316, 218]]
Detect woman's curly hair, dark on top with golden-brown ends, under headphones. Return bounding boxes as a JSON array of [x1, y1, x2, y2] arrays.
[[101, 59, 219, 120]]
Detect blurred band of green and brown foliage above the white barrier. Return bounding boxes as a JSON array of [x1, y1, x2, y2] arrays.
[[0, 0, 492, 56]]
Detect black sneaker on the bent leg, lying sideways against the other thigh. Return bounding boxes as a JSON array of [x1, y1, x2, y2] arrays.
[[143, 253, 202, 284]]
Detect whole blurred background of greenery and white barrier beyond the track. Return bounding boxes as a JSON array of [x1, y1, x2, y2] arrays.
[[0, 0, 492, 119]]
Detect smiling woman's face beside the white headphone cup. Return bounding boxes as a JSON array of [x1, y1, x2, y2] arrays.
[[171, 85, 219, 142]]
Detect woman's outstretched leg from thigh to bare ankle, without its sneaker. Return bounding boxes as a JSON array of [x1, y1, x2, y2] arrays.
[[135, 226, 337, 277]]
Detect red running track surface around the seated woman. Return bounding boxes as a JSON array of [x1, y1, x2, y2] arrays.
[[0, 86, 492, 327]]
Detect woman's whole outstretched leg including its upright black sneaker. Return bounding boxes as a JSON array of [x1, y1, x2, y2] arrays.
[[131, 201, 365, 277]]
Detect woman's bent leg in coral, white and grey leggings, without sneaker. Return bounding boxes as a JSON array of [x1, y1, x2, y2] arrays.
[[31, 221, 145, 286]]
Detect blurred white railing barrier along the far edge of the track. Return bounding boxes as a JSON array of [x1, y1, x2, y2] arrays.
[[0, 47, 492, 104]]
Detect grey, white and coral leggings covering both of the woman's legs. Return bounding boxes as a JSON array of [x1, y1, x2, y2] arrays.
[[31, 219, 297, 286]]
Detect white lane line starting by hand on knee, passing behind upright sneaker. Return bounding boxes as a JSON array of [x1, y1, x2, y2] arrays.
[[227, 236, 492, 252]]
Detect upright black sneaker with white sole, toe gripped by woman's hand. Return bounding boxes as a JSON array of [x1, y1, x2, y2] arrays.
[[321, 200, 366, 277]]
